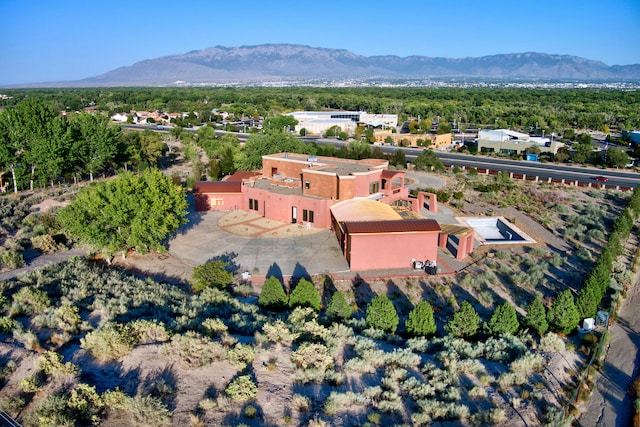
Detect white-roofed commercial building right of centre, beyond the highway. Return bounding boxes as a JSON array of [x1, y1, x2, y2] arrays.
[[478, 129, 564, 155]]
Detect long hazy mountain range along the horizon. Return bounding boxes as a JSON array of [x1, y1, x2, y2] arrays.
[[73, 44, 640, 86]]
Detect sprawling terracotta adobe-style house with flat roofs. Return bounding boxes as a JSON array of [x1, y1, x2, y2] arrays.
[[194, 153, 473, 271]]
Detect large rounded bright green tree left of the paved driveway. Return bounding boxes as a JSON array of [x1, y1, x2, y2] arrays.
[[57, 169, 187, 253]]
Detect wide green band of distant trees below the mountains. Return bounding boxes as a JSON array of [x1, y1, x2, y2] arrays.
[[0, 87, 640, 135]]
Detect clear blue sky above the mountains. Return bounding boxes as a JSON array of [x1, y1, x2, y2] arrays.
[[0, 0, 640, 85]]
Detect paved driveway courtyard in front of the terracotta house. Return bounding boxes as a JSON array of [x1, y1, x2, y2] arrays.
[[169, 212, 349, 276]]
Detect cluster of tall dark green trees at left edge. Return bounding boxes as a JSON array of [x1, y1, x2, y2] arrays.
[[0, 98, 166, 192]]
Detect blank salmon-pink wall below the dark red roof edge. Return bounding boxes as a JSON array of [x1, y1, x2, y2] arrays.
[[347, 232, 438, 271]]
